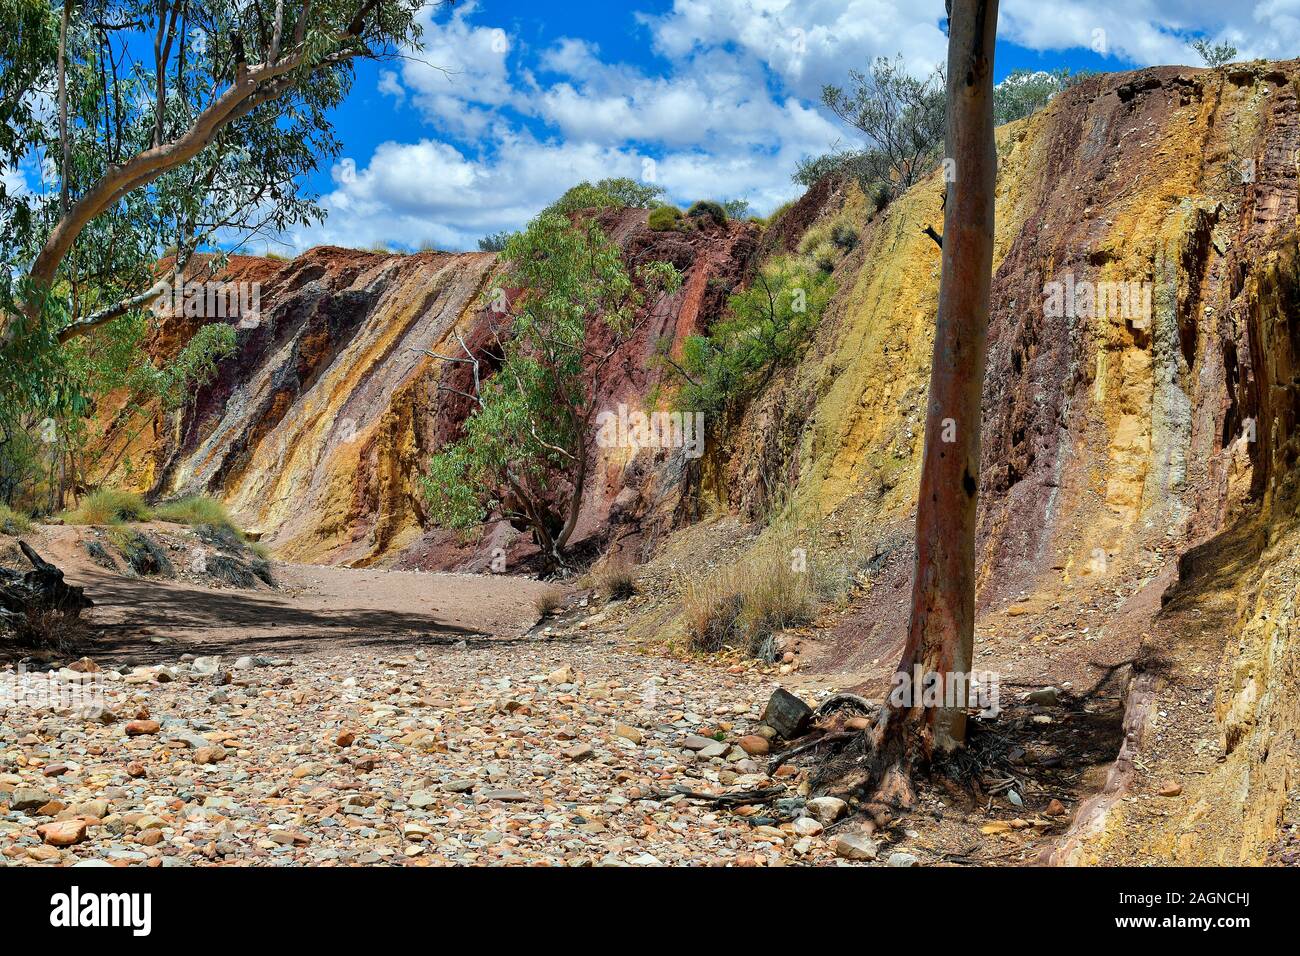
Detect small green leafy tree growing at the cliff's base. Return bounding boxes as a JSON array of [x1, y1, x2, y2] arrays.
[[424, 209, 681, 566]]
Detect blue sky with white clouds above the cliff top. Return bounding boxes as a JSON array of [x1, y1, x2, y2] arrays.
[[285, 0, 1300, 250]]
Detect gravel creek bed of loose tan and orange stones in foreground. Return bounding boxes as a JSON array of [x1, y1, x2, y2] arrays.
[[0, 635, 887, 866]]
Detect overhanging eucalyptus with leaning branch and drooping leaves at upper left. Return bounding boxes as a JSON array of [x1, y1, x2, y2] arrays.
[[0, 0, 423, 509]]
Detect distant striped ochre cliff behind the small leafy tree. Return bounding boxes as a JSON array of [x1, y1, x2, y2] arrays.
[[96, 211, 755, 568]]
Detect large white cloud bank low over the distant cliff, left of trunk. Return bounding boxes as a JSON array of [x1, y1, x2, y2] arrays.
[[291, 4, 863, 248]]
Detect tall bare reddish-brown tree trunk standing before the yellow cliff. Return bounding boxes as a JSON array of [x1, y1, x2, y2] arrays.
[[898, 0, 997, 756]]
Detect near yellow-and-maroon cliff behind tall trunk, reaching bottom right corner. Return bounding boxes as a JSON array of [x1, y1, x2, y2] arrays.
[[710, 62, 1300, 862]]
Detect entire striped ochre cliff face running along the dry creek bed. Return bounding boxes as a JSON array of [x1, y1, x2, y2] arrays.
[[89, 61, 1300, 862]]
